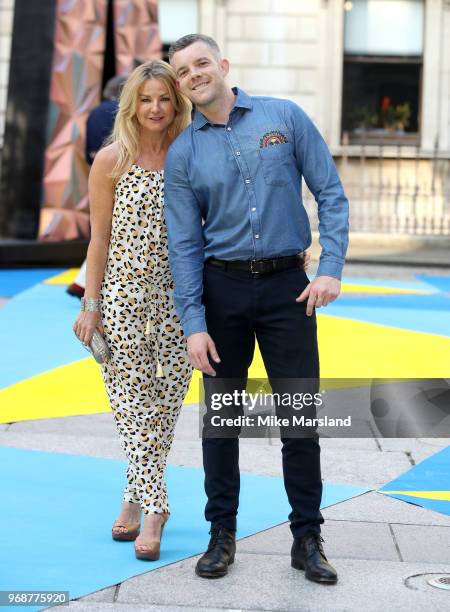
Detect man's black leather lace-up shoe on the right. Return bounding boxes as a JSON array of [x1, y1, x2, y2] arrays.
[[291, 533, 337, 584]]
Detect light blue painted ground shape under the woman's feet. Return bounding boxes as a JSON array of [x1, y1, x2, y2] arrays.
[[0, 448, 370, 610]]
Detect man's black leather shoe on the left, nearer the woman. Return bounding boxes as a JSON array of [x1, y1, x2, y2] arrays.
[[195, 525, 236, 578]]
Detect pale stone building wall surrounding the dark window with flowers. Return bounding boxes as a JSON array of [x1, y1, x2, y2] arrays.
[[178, 0, 450, 235]]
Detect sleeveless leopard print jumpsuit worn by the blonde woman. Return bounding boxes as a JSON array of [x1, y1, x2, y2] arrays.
[[101, 165, 192, 514]]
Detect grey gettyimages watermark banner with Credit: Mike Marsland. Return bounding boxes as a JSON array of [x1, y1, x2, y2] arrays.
[[199, 378, 450, 438]]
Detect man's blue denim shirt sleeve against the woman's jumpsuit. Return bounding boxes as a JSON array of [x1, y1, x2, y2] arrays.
[[164, 145, 207, 337]]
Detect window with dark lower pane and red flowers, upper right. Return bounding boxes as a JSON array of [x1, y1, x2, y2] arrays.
[[342, 0, 424, 143]]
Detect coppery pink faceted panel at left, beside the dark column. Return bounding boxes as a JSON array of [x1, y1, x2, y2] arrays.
[[39, 0, 106, 240]]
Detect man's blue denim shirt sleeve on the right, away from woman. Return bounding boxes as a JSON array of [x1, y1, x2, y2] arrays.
[[286, 101, 349, 279]]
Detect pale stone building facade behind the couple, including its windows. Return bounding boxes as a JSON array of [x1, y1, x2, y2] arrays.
[[0, 0, 450, 235]]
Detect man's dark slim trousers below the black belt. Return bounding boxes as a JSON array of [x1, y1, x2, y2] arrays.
[[202, 264, 324, 537]]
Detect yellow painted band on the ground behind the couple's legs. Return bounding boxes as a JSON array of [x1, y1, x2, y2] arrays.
[[0, 315, 450, 423]]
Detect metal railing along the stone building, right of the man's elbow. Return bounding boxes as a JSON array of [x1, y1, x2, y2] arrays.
[[304, 137, 450, 236]]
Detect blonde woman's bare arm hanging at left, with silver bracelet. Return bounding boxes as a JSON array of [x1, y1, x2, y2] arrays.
[[73, 145, 116, 344]]
